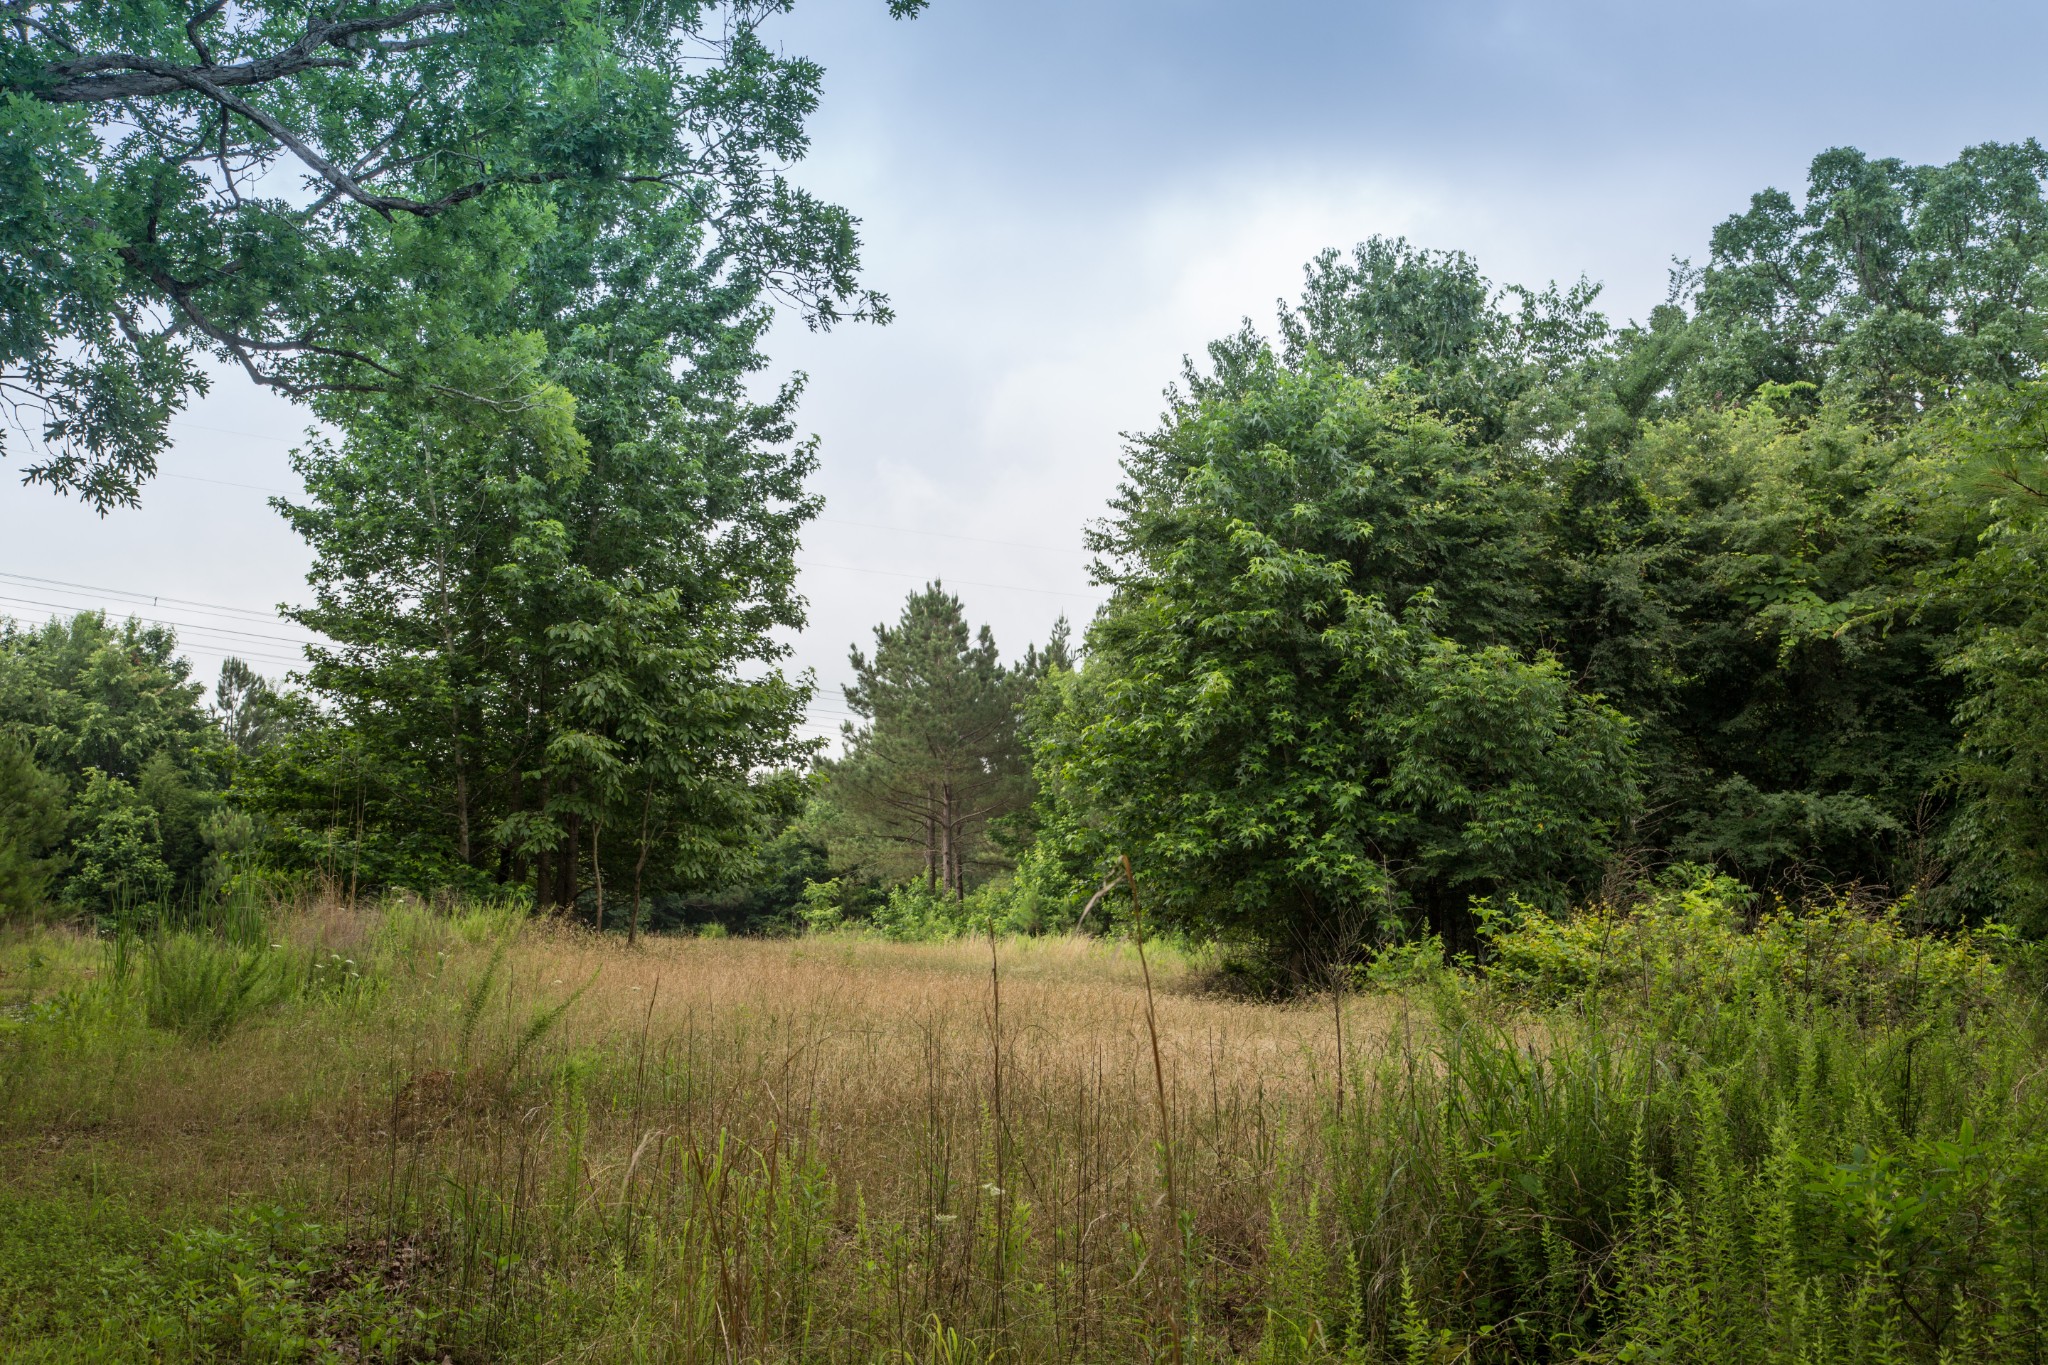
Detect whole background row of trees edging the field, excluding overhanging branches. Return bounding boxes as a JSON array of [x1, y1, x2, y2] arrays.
[[0, 141, 2048, 970]]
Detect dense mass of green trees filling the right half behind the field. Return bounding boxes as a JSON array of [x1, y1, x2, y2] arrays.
[[1034, 143, 2048, 954]]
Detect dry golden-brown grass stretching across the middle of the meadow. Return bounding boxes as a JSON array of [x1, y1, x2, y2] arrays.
[[8, 905, 1393, 1359]]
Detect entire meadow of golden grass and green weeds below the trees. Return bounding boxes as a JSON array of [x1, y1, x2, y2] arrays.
[[0, 902, 2048, 1361]]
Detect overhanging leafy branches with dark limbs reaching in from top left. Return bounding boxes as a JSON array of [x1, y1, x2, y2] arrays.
[[0, 0, 924, 510]]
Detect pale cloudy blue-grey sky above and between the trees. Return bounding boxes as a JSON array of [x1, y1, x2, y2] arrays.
[[0, 0, 2048, 749]]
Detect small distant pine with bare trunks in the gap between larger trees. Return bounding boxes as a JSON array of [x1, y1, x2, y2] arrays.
[[819, 583, 1040, 898]]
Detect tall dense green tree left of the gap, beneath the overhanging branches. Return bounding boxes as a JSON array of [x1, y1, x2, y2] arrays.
[[252, 313, 815, 907]]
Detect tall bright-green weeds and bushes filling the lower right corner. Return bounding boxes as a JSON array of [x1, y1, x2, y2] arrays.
[[1333, 925, 2048, 1365]]
